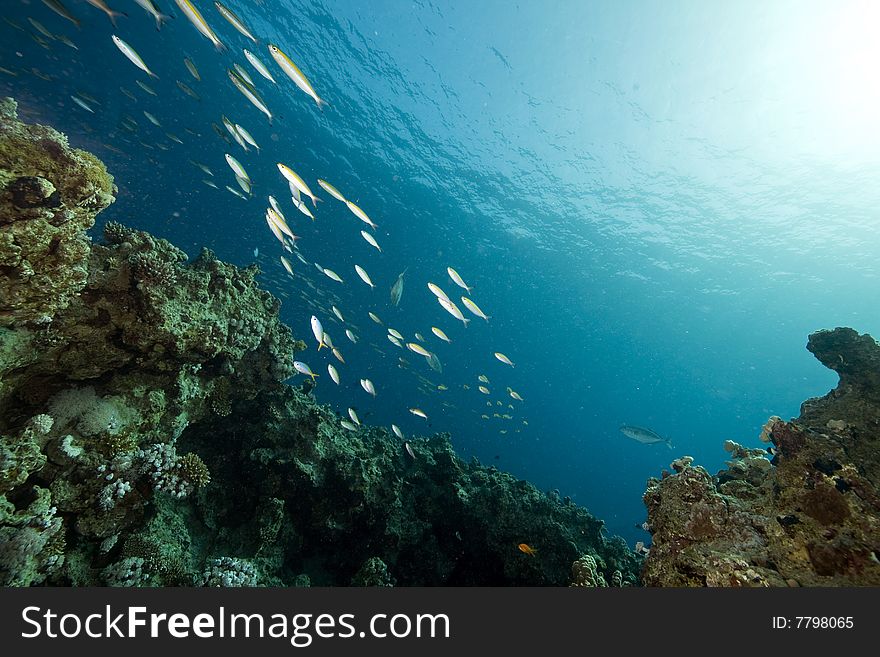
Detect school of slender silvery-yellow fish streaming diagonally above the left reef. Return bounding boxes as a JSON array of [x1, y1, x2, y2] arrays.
[[0, 0, 533, 446]]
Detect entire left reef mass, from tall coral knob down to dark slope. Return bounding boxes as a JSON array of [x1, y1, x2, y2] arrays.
[[0, 99, 639, 586]]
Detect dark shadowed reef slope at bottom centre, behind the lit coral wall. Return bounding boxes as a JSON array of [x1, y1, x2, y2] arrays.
[[172, 388, 640, 586]]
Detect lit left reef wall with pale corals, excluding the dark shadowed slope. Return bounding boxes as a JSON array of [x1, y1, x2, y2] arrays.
[[0, 99, 299, 585]]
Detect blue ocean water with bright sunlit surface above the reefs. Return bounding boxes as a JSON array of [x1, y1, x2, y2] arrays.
[[0, 0, 880, 543]]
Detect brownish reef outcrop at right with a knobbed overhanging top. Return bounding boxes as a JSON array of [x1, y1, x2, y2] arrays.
[[643, 328, 880, 586]]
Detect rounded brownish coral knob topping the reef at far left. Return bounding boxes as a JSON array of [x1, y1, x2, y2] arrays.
[[0, 98, 116, 328]]
